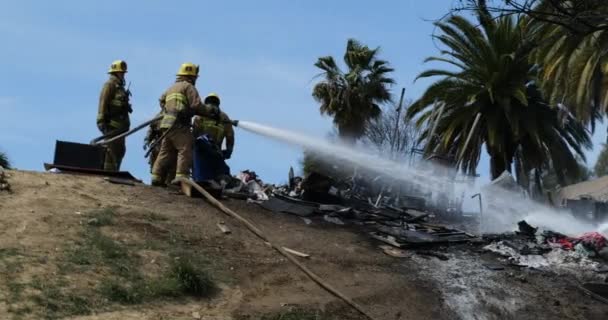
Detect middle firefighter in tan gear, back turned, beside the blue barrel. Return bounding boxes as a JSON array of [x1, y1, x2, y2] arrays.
[[152, 63, 219, 186]]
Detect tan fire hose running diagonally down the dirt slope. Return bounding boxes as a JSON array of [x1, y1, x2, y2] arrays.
[[177, 177, 376, 320]]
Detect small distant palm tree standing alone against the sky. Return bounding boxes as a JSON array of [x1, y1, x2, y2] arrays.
[[312, 39, 394, 143]]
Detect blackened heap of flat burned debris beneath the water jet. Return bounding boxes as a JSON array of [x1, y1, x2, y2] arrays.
[[249, 171, 476, 248]]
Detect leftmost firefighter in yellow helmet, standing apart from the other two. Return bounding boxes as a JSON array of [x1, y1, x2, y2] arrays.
[[97, 60, 133, 171]]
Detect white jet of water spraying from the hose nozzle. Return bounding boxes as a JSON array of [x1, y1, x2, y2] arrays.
[[239, 121, 608, 236]]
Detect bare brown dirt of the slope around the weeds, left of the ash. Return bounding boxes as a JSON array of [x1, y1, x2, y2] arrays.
[[0, 171, 447, 319]]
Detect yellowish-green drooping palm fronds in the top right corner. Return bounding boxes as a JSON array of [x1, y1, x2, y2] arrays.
[[530, 0, 608, 129]]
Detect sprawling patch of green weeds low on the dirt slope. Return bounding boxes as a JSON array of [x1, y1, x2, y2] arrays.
[[21, 208, 222, 318]]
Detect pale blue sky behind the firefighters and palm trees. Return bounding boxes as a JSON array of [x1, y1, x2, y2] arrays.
[[0, 0, 606, 182]]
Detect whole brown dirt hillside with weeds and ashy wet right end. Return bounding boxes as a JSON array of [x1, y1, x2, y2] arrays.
[[0, 171, 608, 320]]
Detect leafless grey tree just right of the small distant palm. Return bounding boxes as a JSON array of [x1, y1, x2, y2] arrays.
[[362, 101, 420, 160]]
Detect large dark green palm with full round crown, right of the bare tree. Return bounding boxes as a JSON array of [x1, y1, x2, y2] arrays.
[[407, 10, 591, 183]]
